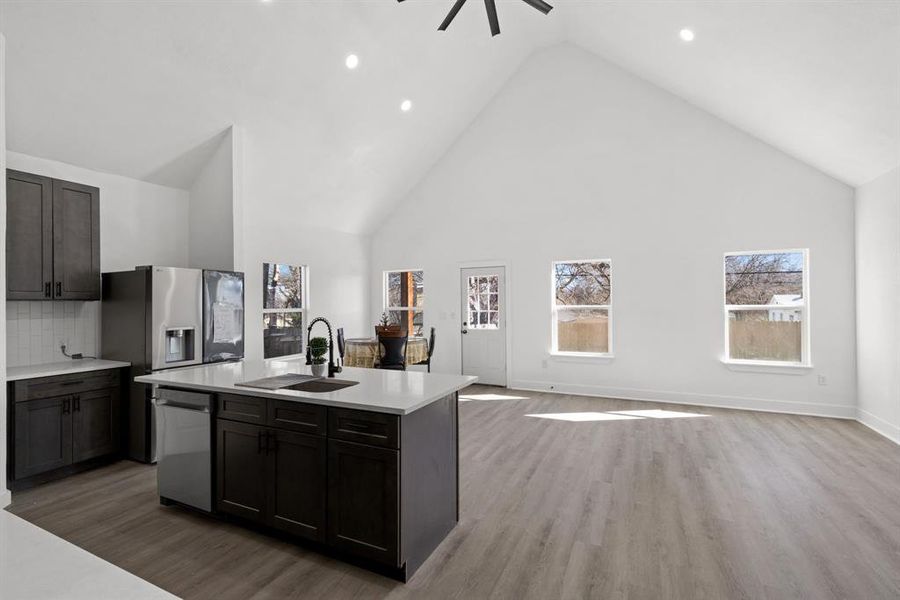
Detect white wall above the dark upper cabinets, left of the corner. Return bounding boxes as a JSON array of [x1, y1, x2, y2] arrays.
[[7, 151, 189, 271]]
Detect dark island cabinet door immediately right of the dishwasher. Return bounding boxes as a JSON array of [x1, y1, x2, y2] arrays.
[[216, 419, 266, 523]]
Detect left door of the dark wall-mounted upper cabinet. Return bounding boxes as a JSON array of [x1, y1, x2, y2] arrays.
[[6, 171, 53, 300]]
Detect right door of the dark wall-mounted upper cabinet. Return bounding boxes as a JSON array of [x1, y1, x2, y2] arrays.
[[53, 179, 100, 300]]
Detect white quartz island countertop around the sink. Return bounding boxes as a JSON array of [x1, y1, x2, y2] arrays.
[[135, 359, 478, 415]]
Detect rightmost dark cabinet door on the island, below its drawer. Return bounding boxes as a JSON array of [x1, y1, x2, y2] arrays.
[[328, 439, 400, 567]]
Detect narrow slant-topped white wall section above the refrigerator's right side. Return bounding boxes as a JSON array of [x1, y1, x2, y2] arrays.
[[188, 129, 234, 271]]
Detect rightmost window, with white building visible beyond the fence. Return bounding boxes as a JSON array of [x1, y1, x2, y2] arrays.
[[725, 250, 809, 364]]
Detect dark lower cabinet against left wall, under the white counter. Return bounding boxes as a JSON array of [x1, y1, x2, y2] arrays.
[[7, 369, 123, 490]]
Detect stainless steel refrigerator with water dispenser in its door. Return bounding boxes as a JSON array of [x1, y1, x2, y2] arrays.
[[100, 266, 244, 462]]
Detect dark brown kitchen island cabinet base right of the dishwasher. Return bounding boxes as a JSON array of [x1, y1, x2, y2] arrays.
[[207, 392, 459, 581]]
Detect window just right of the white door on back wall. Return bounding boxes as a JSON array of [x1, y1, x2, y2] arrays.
[[551, 260, 612, 355]]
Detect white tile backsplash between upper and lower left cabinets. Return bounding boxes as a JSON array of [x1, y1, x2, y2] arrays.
[[6, 301, 100, 367]]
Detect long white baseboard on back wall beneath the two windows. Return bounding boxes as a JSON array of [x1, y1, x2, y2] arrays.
[[510, 379, 857, 419]]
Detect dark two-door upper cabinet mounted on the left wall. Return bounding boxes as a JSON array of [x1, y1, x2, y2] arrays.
[[6, 170, 100, 300]]
